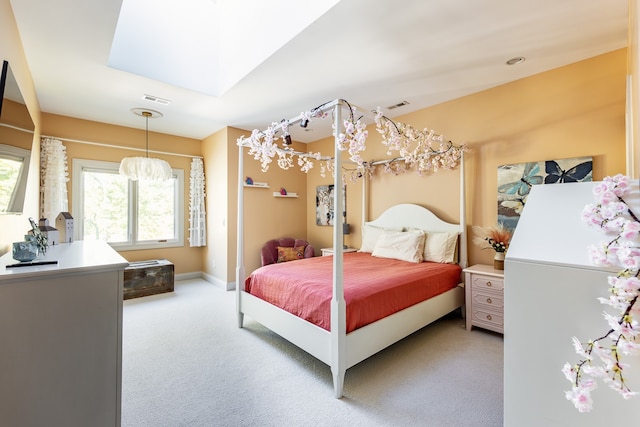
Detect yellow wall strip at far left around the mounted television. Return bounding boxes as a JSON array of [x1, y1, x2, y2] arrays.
[[0, 0, 40, 255]]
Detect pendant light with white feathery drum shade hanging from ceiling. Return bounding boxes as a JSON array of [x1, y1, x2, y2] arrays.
[[120, 108, 173, 181]]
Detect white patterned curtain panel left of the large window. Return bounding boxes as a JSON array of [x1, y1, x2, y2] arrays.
[[40, 138, 69, 227]]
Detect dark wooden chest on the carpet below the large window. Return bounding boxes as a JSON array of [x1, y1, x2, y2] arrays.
[[124, 259, 174, 299]]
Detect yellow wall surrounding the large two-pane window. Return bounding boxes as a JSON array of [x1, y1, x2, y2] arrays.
[[42, 113, 206, 274]]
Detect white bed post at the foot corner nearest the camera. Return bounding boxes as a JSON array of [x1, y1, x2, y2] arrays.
[[331, 102, 347, 398]]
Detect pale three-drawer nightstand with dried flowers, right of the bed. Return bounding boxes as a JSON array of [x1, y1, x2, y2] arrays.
[[463, 264, 504, 334]]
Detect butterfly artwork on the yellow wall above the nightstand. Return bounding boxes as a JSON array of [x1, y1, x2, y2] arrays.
[[498, 157, 593, 231]]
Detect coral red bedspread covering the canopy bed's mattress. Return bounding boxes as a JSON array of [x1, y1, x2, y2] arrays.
[[245, 252, 462, 333]]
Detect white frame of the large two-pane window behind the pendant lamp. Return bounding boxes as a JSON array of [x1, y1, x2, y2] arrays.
[[71, 159, 185, 251]]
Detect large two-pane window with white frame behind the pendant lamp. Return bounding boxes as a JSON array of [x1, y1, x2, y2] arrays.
[[72, 159, 184, 250]]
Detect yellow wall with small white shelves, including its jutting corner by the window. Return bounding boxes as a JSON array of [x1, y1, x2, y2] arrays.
[[202, 127, 311, 287]]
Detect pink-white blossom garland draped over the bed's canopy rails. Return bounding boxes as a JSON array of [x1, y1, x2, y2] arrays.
[[238, 100, 468, 181]]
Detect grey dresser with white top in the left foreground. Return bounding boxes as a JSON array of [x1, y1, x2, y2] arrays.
[[0, 241, 128, 427]]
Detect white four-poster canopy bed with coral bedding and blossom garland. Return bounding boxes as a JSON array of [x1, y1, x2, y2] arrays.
[[236, 100, 467, 398]]
